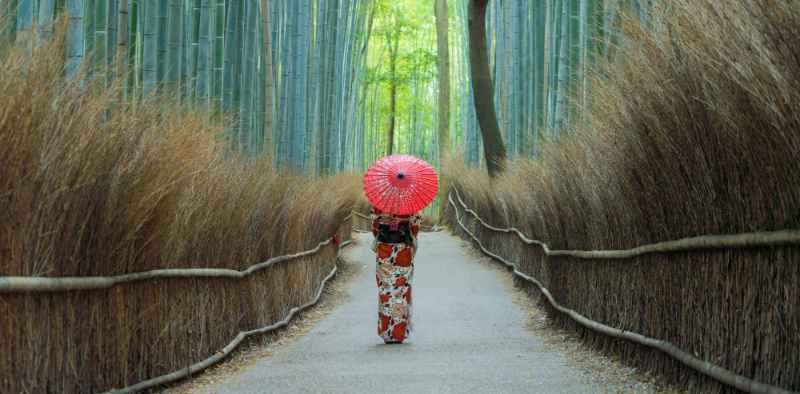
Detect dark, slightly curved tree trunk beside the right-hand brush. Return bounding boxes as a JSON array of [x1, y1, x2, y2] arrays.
[[469, 0, 506, 177]]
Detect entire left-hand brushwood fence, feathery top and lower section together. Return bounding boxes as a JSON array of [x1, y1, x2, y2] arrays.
[[0, 29, 360, 392]]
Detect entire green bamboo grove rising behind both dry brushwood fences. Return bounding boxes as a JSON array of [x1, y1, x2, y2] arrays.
[[0, 0, 654, 174]]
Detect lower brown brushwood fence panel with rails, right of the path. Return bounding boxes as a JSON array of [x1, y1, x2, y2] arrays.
[[447, 189, 800, 393]]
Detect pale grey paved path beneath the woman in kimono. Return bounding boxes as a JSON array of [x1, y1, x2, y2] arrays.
[[205, 232, 636, 393]]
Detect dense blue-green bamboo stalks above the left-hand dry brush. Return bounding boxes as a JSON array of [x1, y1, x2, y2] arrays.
[[0, 0, 368, 173]]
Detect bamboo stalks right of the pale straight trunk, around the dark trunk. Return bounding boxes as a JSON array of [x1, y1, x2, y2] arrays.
[[450, 0, 655, 165]]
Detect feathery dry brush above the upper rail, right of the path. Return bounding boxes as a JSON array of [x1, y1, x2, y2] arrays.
[[450, 0, 800, 249]]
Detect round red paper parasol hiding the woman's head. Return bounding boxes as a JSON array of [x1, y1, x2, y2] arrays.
[[364, 155, 439, 215]]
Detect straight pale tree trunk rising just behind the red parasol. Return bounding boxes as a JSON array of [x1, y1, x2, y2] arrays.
[[434, 0, 450, 209]]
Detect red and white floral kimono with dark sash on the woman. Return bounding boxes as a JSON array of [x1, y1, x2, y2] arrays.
[[371, 208, 422, 343]]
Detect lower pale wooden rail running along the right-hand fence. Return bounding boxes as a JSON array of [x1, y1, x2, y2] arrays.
[[447, 189, 791, 394]]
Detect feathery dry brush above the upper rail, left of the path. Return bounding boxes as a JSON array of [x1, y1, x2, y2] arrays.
[[0, 28, 358, 276]]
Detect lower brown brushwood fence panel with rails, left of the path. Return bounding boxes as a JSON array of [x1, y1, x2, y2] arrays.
[[0, 215, 353, 392]]
